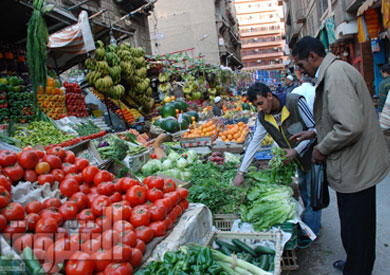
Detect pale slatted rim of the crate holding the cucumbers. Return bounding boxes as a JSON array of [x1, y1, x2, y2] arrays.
[[204, 231, 282, 275]]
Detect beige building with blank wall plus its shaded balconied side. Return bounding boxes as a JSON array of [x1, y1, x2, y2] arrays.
[[149, 0, 241, 69]]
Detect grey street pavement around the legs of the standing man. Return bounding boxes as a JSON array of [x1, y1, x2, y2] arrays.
[[282, 181, 390, 275]]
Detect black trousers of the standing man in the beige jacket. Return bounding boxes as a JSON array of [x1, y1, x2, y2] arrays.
[[337, 186, 376, 275]]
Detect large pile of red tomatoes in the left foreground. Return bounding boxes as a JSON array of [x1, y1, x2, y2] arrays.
[[0, 147, 188, 275]]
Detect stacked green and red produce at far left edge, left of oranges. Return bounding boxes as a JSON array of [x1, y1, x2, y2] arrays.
[[0, 76, 34, 123]]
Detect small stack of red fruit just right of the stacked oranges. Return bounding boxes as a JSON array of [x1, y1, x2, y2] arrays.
[[64, 82, 88, 117]]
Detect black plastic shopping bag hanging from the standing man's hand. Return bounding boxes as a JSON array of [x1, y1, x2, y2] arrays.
[[310, 163, 329, 210]]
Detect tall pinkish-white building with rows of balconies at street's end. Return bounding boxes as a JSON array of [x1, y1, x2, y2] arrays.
[[235, 0, 286, 70]]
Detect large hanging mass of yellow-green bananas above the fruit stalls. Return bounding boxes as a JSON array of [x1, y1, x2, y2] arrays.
[[85, 41, 154, 113]]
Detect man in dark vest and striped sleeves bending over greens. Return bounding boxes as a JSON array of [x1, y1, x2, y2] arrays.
[[233, 82, 321, 248]]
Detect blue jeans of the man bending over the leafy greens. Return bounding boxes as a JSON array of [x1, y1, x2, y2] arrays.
[[297, 168, 322, 235]]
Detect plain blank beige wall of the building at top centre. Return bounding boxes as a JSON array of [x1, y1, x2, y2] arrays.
[[149, 0, 220, 64]]
